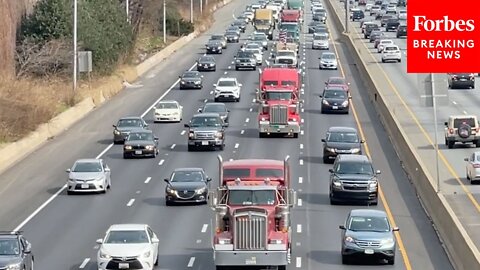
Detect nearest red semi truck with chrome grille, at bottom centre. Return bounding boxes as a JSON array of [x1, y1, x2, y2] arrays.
[[209, 156, 297, 270]]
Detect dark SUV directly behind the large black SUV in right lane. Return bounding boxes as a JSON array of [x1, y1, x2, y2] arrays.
[[322, 127, 364, 163]]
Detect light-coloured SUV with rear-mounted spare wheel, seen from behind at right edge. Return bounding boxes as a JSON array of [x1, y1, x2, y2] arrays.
[[445, 115, 480, 149]]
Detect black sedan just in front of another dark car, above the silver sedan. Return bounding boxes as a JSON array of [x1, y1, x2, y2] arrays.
[[123, 130, 158, 158]]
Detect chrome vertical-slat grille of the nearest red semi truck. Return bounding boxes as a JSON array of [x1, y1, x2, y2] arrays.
[[234, 212, 267, 250]]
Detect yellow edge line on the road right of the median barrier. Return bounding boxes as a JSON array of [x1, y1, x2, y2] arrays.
[[348, 22, 480, 212]]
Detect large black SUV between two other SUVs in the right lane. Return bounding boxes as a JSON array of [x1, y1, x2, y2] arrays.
[[329, 154, 380, 205]]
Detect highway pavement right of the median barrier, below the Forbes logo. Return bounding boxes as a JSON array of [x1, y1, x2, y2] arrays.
[[332, 1, 480, 255]]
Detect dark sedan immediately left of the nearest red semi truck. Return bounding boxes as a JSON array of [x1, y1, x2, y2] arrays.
[[165, 168, 212, 205]]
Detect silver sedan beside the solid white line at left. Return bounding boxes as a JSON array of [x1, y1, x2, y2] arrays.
[[67, 159, 112, 194]]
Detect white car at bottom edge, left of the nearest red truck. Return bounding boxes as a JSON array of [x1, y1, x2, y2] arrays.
[[97, 224, 159, 270]]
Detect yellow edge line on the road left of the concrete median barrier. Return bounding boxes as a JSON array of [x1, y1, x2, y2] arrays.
[[327, 17, 412, 270]]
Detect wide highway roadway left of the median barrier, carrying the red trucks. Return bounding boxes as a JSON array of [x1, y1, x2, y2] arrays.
[[0, 1, 453, 270]]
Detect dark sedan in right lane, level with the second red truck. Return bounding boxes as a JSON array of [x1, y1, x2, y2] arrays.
[[320, 86, 350, 114]]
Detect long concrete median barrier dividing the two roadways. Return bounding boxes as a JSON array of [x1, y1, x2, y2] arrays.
[[325, 0, 480, 270]]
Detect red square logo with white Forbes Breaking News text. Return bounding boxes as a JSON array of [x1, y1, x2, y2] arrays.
[[407, 0, 480, 73]]
